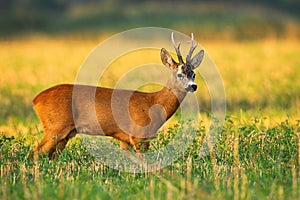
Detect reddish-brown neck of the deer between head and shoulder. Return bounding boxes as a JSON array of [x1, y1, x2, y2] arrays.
[[156, 77, 187, 119]]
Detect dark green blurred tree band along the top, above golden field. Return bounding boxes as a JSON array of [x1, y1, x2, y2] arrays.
[[0, 0, 300, 40]]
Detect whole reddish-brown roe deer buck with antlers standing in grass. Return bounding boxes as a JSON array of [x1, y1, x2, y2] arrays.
[[33, 33, 204, 159]]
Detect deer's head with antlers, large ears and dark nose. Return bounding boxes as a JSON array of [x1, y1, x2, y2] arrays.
[[160, 32, 204, 92]]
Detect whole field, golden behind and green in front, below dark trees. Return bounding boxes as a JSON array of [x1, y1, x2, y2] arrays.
[[0, 36, 300, 199]]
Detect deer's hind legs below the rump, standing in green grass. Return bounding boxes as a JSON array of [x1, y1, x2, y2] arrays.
[[34, 126, 76, 159]]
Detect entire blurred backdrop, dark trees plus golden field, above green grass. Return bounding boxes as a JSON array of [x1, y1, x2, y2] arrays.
[[0, 0, 300, 128]]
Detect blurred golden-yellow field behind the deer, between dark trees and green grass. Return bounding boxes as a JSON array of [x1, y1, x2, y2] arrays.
[[0, 36, 300, 138]]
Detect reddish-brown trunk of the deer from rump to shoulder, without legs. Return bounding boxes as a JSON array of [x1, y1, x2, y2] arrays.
[[33, 84, 161, 138]]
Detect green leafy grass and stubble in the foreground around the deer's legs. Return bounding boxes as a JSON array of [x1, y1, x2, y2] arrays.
[[0, 117, 300, 199]]
